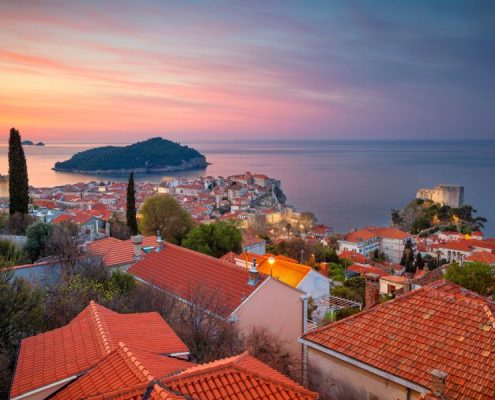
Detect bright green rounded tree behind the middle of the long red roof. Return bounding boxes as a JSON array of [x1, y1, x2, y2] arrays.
[[182, 221, 242, 258]]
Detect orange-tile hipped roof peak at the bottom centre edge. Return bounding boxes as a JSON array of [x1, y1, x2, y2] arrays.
[[161, 353, 318, 400]]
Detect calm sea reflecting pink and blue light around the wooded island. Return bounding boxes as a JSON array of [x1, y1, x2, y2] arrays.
[[0, 141, 495, 236]]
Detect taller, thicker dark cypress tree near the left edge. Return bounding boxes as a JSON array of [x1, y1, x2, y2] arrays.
[[9, 128, 29, 215]]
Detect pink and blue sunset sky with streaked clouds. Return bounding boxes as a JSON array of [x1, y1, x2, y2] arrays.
[[0, 0, 495, 143]]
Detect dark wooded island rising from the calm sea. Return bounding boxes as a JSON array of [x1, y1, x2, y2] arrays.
[[53, 137, 207, 174]]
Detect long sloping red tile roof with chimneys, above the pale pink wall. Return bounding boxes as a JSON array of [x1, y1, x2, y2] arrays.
[[128, 243, 266, 317]]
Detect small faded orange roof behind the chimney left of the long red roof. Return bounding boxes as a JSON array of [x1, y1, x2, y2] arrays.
[[88, 236, 157, 267]]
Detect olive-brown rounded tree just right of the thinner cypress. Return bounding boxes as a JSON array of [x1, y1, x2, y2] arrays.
[[139, 194, 193, 244]]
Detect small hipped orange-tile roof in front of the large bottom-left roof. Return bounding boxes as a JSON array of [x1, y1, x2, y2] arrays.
[[52, 342, 194, 400]]
